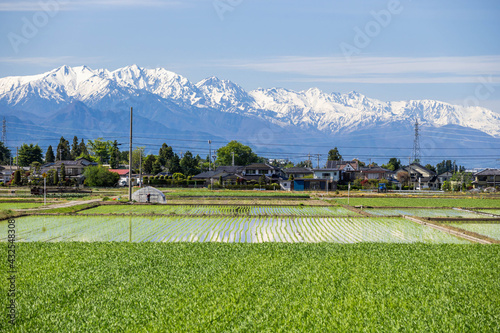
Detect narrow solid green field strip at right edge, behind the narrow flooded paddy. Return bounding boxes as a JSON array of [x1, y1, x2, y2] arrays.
[[334, 197, 500, 209]]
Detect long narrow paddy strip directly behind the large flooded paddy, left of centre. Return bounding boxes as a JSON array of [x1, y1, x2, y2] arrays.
[[80, 205, 359, 216]]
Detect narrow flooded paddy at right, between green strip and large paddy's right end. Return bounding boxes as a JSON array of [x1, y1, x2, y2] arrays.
[[363, 208, 482, 218]]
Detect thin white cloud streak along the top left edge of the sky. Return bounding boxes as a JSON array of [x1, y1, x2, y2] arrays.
[[0, 0, 188, 12]]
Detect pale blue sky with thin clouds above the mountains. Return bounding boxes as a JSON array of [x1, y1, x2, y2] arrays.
[[0, 0, 500, 112]]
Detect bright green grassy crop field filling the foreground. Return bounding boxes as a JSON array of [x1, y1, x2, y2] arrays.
[[0, 243, 500, 332]]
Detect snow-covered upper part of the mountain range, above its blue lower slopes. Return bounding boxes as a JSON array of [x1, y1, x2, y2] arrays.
[[0, 65, 500, 137]]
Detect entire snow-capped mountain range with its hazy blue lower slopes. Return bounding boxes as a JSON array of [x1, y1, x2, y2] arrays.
[[0, 65, 500, 165]]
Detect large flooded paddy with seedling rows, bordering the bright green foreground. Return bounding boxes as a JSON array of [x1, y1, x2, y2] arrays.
[[0, 215, 469, 244]]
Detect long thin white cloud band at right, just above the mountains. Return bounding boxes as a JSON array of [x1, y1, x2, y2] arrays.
[[217, 56, 500, 83]]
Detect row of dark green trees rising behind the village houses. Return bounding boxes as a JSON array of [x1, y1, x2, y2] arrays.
[[6, 136, 465, 176]]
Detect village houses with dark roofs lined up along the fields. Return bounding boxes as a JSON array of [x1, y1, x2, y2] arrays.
[[0, 158, 500, 191]]
